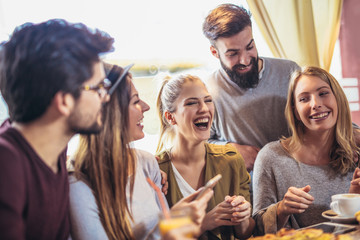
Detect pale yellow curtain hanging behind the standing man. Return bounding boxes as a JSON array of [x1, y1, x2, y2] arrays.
[[247, 0, 343, 71]]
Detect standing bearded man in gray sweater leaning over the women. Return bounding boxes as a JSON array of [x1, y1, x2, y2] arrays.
[[203, 4, 299, 172]]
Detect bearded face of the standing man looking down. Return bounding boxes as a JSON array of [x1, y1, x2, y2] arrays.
[[211, 26, 259, 89]]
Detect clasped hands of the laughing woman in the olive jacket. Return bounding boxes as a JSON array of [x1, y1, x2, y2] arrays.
[[201, 196, 251, 232]]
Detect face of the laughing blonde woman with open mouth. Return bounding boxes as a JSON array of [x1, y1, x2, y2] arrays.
[[165, 80, 214, 141]]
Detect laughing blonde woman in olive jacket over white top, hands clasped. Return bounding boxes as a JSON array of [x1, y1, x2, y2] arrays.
[[157, 75, 254, 239]]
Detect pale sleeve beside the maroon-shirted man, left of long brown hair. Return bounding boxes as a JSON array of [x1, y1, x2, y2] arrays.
[[70, 177, 108, 240]]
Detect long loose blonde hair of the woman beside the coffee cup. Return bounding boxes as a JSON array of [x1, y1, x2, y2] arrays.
[[283, 67, 359, 174]]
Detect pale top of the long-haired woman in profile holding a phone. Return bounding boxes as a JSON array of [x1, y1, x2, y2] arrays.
[[70, 150, 166, 240]]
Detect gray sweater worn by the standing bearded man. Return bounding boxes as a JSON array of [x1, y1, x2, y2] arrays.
[[206, 58, 299, 148]]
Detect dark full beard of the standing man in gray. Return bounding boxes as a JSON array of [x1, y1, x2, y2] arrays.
[[220, 57, 259, 89]]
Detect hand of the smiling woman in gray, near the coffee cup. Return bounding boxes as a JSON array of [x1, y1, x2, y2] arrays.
[[277, 185, 314, 225]]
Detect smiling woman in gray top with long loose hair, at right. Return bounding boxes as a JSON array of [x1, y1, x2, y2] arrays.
[[253, 67, 360, 235]]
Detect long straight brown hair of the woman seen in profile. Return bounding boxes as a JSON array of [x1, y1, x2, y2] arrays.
[[74, 66, 135, 240]]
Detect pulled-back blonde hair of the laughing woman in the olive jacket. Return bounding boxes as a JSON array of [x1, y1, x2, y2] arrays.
[[156, 74, 202, 154]]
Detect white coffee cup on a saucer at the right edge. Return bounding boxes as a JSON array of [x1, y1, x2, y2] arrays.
[[330, 193, 360, 217]]
